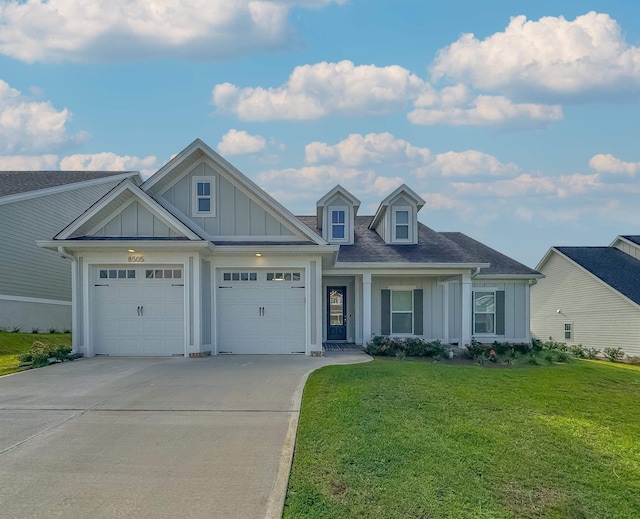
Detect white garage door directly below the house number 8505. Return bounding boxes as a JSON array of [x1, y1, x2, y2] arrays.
[[93, 265, 184, 355]]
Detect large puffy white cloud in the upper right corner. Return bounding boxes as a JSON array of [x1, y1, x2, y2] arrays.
[[432, 12, 640, 97]]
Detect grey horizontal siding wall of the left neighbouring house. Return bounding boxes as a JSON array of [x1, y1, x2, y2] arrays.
[[0, 181, 119, 301]]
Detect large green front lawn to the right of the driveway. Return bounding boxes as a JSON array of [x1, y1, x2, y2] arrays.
[[284, 359, 640, 519]]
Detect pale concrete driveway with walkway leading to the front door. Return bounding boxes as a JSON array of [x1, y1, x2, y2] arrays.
[[0, 353, 369, 519]]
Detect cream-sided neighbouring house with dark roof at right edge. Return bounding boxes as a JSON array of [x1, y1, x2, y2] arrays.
[[531, 236, 640, 355]]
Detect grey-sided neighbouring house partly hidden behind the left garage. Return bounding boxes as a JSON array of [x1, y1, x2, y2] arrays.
[[0, 171, 142, 332]]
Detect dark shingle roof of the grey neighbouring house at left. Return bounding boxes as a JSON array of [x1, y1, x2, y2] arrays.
[[0, 171, 137, 196]]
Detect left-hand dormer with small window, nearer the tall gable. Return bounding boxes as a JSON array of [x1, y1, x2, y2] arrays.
[[316, 184, 360, 245]]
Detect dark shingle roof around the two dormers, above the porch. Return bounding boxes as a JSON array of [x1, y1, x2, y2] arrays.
[[298, 216, 539, 275]]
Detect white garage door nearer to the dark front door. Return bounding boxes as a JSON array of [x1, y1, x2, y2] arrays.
[[216, 269, 306, 354]]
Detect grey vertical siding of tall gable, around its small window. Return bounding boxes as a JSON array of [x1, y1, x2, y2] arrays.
[[160, 162, 293, 238]]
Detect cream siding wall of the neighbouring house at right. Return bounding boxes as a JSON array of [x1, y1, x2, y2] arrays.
[[531, 251, 640, 355]]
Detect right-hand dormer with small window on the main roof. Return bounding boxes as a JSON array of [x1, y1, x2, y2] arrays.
[[369, 184, 425, 245]]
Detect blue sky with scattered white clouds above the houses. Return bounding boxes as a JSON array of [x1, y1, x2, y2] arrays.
[[0, 0, 640, 266]]
